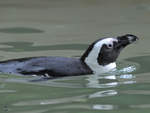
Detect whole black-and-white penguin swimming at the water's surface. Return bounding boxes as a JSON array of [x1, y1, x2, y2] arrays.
[[0, 34, 138, 78]]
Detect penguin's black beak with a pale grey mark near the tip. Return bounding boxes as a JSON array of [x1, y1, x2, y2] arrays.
[[115, 34, 138, 49]]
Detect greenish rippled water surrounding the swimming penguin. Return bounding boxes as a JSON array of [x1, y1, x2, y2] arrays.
[[0, 0, 150, 113]]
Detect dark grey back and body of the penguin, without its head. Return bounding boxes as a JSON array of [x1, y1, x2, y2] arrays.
[[0, 56, 92, 77]]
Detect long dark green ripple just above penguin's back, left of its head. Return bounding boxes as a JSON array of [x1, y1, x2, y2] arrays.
[[0, 42, 88, 52]]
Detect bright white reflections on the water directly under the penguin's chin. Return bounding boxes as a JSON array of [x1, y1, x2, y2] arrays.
[[86, 66, 136, 88]]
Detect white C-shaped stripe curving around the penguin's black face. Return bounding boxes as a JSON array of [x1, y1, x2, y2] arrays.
[[85, 38, 118, 74]]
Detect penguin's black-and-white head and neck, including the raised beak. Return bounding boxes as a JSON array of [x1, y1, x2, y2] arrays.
[[81, 34, 138, 74]]
